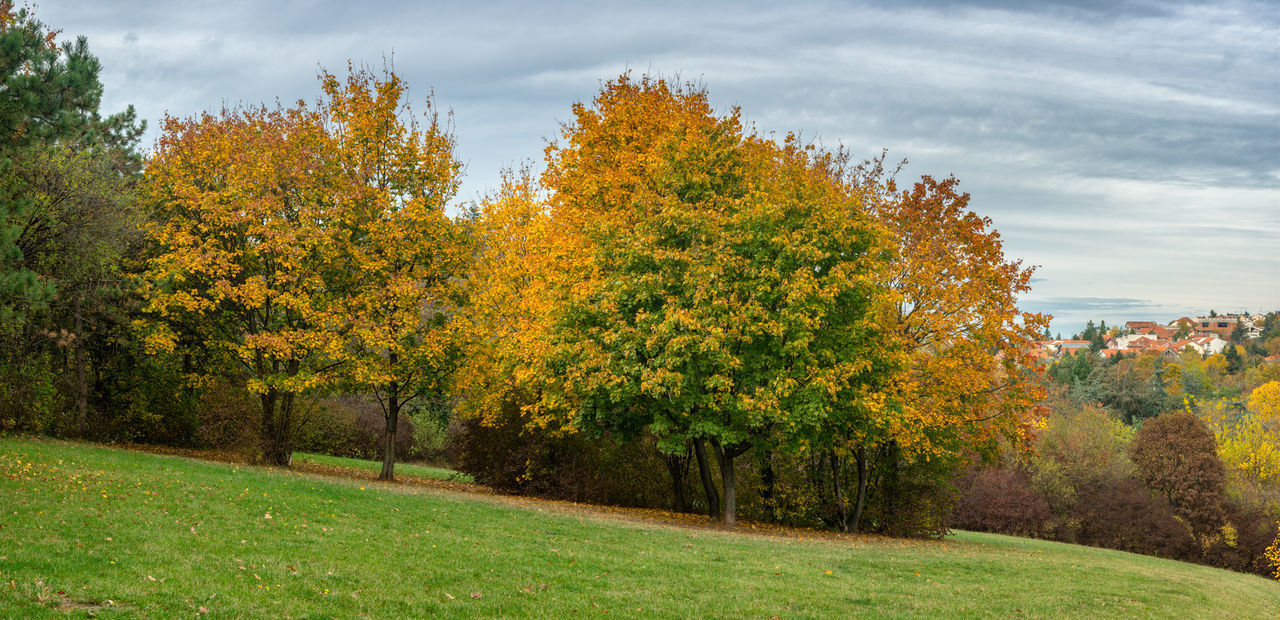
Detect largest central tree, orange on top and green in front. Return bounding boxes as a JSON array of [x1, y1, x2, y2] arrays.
[[544, 76, 886, 526]]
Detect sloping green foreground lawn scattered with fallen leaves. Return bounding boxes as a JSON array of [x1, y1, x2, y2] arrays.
[[0, 439, 1280, 617]]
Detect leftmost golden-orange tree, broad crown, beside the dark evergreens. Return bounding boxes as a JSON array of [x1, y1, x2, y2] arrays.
[[145, 102, 351, 465]]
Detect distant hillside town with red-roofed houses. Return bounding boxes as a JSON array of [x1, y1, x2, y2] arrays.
[[1036, 311, 1280, 363]]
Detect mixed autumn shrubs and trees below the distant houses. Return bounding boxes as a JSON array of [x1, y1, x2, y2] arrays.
[[955, 335, 1280, 576]]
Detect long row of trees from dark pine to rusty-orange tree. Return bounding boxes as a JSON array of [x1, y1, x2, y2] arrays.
[[0, 8, 1046, 535]]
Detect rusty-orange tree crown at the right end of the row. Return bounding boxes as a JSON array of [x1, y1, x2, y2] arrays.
[[861, 169, 1049, 527]]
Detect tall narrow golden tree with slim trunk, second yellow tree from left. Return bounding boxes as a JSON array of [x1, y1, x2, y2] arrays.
[[321, 69, 470, 480]]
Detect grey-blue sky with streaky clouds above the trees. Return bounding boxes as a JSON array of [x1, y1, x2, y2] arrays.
[[36, 0, 1280, 334]]
